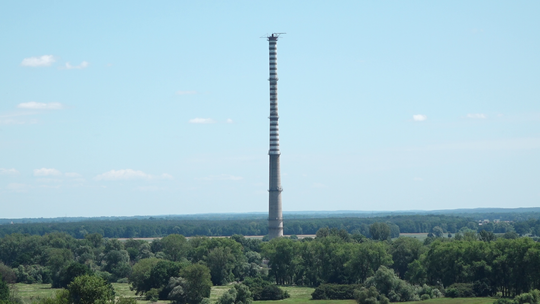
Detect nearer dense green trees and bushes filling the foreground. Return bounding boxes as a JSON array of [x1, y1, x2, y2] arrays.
[[0, 220, 540, 304]]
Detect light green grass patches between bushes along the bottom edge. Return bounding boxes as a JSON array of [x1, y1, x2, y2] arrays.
[[11, 283, 494, 304]]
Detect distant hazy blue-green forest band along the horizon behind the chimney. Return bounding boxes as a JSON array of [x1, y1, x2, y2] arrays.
[[0, 215, 540, 239]]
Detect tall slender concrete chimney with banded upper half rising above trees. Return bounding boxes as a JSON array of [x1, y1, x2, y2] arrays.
[[267, 33, 283, 239]]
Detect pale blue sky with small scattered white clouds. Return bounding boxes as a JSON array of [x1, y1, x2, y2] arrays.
[[0, 1, 540, 218]]
